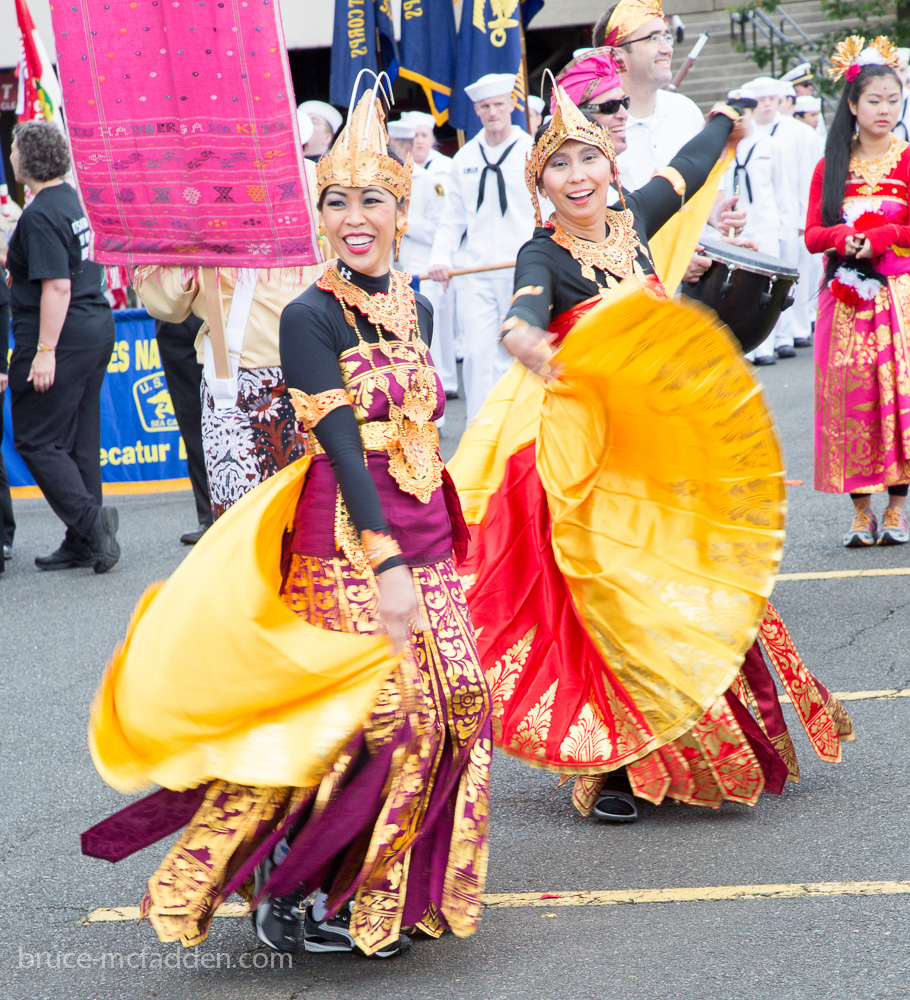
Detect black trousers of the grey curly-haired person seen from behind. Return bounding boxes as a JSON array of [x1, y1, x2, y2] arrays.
[[9, 340, 114, 547]]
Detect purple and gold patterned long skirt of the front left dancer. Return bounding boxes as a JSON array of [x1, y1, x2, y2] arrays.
[[137, 554, 492, 953]]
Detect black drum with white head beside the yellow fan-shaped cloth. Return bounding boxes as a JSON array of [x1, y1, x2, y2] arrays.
[[682, 238, 799, 353]]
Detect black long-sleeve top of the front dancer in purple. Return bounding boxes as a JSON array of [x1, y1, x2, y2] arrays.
[[279, 269, 433, 569]]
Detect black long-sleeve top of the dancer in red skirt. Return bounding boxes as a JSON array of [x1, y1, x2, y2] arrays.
[[506, 115, 733, 330]]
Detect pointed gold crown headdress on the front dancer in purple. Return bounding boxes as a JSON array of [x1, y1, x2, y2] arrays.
[[316, 70, 413, 201]]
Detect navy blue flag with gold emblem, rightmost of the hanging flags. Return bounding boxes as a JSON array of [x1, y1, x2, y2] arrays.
[[449, 0, 543, 137]]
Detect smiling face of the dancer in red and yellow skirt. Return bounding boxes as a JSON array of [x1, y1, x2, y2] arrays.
[[540, 139, 613, 225]]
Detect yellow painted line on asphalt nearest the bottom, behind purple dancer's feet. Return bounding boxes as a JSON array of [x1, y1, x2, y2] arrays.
[[82, 881, 910, 924]]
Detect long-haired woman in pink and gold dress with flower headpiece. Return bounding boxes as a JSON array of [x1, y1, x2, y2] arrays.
[[805, 35, 910, 548]]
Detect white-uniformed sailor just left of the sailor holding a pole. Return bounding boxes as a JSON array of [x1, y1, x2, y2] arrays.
[[389, 111, 458, 399]]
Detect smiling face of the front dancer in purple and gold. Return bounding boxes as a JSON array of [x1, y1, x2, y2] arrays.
[[321, 184, 407, 277]]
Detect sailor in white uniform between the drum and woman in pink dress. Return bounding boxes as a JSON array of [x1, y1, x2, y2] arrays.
[[742, 76, 821, 363]]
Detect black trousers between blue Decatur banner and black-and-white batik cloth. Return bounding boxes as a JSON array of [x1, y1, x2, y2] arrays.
[[155, 316, 212, 524]]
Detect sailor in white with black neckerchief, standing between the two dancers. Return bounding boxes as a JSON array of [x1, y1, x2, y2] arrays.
[[429, 73, 534, 421]]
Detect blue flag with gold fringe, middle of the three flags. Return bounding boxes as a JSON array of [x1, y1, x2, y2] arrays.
[[400, 0, 455, 125]]
